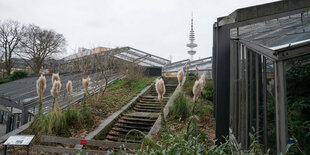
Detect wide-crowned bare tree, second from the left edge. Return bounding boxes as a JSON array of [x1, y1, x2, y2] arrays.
[[21, 25, 66, 73]]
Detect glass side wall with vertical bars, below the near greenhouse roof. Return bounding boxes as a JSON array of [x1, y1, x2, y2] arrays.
[[235, 45, 276, 150]]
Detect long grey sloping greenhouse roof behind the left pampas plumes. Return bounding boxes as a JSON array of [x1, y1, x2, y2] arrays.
[[0, 73, 119, 113]]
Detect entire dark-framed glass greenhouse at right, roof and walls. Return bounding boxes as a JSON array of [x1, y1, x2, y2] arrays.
[[214, 0, 310, 154]]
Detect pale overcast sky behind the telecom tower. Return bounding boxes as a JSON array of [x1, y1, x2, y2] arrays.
[[0, 0, 275, 61]]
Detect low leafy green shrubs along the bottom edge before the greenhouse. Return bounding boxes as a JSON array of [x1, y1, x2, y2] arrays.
[[138, 134, 269, 155]]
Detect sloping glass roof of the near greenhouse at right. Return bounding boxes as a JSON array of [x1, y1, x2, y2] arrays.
[[230, 12, 310, 54]]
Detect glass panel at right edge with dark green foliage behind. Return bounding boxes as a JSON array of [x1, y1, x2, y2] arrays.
[[284, 55, 310, 154]]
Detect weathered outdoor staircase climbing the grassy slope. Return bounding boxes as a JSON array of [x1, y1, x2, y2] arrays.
[[106, 78, 177, 143]]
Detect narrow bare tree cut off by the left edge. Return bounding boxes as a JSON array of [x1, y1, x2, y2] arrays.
[[0, 20, 22, 75]]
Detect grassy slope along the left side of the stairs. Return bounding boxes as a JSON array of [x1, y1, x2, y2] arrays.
[[71, 77, 155, 138]]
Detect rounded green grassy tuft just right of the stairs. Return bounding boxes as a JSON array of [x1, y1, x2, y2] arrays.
[[169, 92, 192, 120]]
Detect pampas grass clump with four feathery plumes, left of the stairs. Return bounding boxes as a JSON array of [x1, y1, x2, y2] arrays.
[[28, 74, 94, 141]]
